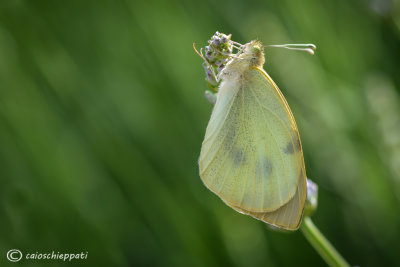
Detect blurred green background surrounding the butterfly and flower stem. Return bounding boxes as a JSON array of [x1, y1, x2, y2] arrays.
[[0, 0, 400, 267]]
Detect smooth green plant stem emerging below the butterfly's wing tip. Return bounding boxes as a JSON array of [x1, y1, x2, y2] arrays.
[[300, 216, 350, 267]]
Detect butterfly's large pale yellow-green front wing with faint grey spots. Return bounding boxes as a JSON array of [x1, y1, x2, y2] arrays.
[[199, 66, 304, 217]]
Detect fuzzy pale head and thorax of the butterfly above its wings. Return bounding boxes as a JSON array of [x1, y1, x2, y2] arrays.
[[221, 41, 265, 79]]
